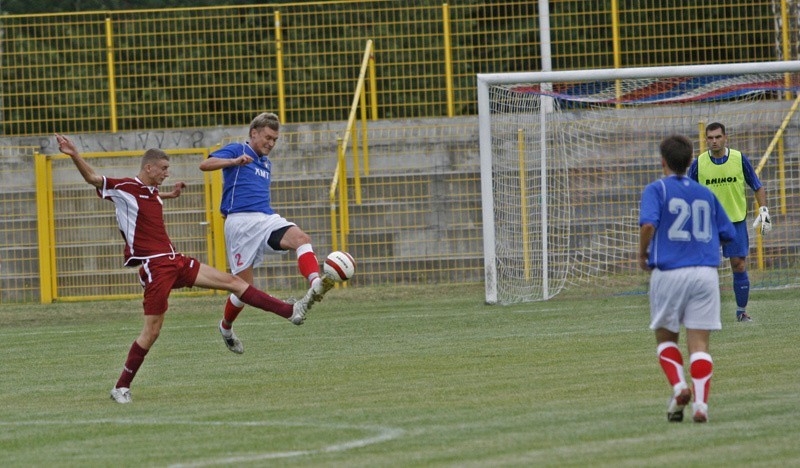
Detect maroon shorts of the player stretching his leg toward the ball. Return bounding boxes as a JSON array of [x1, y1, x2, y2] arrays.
[[139, 254, 200, 315]]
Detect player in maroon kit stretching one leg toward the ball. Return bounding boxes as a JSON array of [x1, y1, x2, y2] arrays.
[[56, 134, 311, 403]]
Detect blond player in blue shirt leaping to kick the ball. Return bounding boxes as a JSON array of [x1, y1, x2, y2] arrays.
[[200, 112, 334, 354]]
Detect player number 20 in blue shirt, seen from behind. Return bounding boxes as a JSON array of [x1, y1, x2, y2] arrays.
[[639, 135, 736, 422]]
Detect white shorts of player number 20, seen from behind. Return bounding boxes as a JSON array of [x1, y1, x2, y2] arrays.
[[650, 266, 722, 333]]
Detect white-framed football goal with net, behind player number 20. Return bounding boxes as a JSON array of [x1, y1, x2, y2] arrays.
[[478, 62, 800, 304]]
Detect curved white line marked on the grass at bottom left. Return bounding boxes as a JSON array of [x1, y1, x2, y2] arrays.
[[0, 419, 405, 468]]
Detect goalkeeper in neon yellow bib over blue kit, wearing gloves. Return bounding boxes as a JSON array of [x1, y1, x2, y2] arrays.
[[689, 122, 772, 322]]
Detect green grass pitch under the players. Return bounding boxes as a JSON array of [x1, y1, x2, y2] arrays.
[[0, 286, 800, 467]]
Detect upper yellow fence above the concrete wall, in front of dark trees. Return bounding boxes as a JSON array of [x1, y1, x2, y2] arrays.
[[0, 0, 798, 135]]
